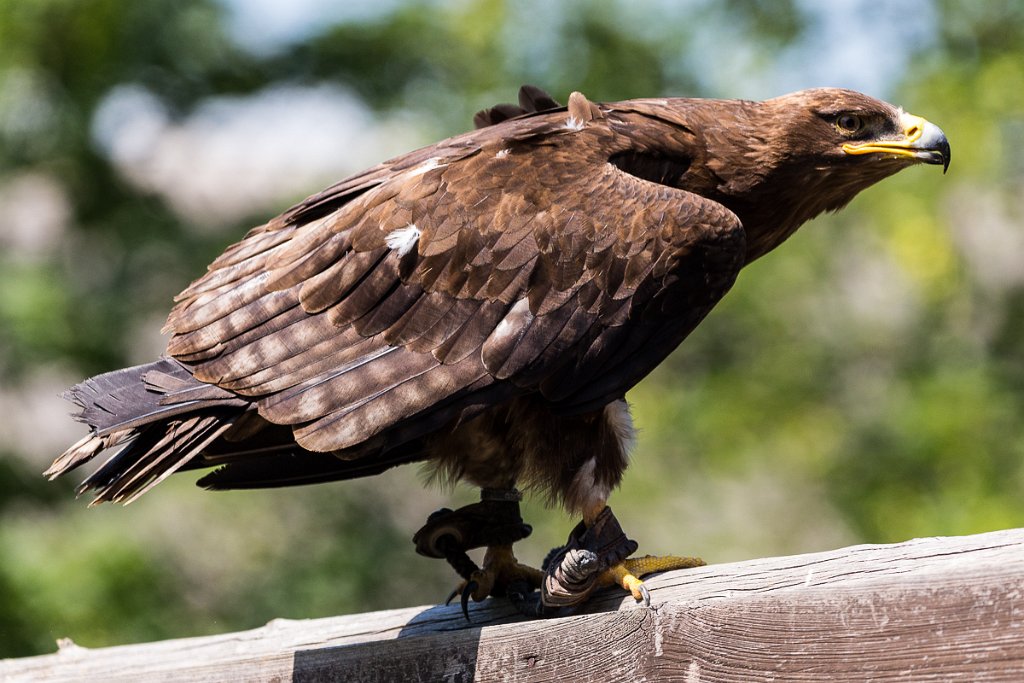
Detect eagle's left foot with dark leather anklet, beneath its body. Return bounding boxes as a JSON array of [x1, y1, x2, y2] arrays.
[[413, 488, 543, 618]]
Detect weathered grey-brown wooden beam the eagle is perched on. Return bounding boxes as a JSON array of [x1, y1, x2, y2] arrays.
[[6, 529, 1024, 683]]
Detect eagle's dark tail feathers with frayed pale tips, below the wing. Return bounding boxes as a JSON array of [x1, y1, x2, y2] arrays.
[[44, 358, 450, 505]]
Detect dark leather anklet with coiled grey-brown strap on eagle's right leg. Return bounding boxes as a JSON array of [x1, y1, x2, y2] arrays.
[[541, 507, 637, 608]]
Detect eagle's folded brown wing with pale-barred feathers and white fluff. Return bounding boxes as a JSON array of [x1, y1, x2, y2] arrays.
[[56, 89, 743, 497]]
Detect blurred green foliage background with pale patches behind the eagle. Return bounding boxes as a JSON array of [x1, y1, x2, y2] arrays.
[[0, 0, 1024, 656]]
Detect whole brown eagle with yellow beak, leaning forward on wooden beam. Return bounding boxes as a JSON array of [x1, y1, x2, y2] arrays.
[[46, 86, 950, 616]]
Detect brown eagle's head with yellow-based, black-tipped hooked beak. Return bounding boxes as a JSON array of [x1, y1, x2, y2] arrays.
[[723, 88, 950, 259]]
